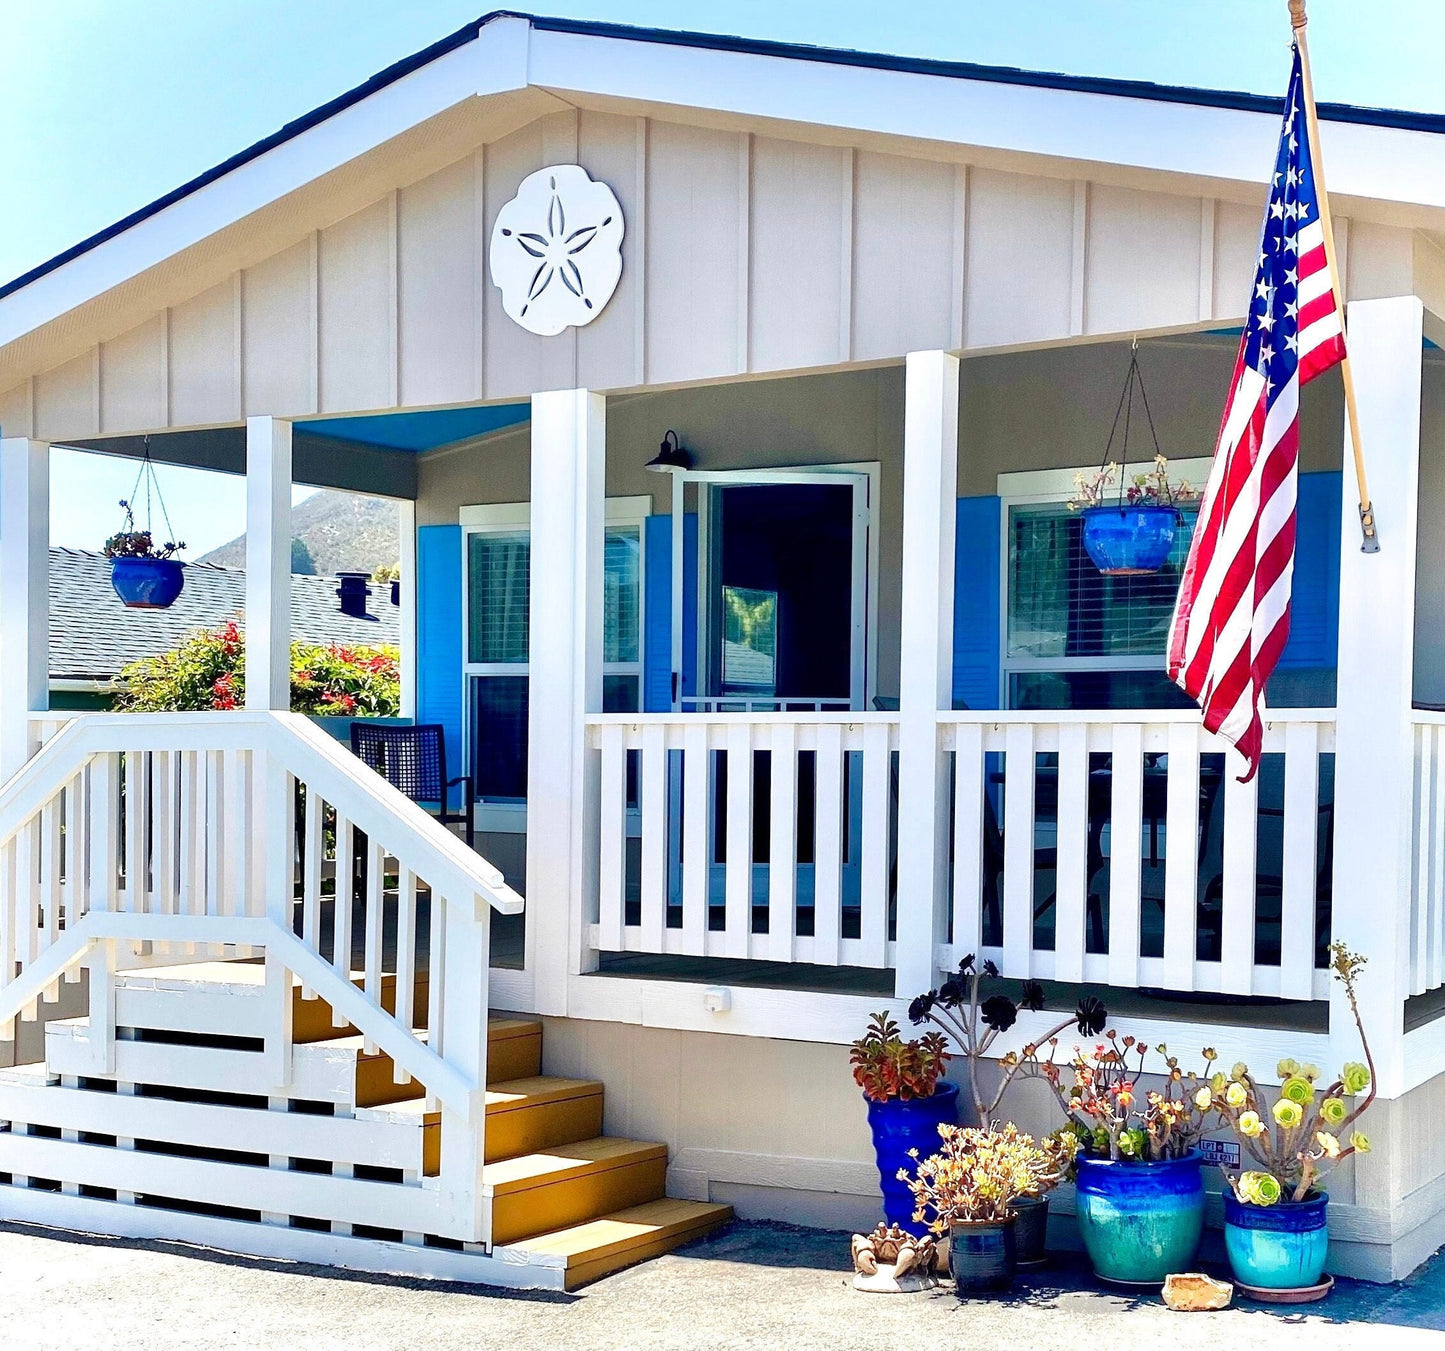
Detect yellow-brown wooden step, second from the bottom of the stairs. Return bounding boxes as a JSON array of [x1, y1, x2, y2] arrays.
[[481, 1136, 668, 1243]]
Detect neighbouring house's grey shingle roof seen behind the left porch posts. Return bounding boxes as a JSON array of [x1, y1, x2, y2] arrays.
[[51, 549, 402, 681]]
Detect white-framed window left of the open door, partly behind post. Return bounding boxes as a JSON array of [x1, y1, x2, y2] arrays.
[[461, 497, 652, 809]]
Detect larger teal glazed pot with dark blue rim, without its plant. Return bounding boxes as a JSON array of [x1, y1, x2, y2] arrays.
[[1075, 1150, 1204, 1285]]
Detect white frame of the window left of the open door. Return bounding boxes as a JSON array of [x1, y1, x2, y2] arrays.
[[458, 493, 652, 834]]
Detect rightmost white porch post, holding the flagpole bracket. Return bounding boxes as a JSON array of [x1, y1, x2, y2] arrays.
[[1329, 296, 1423, 1094]]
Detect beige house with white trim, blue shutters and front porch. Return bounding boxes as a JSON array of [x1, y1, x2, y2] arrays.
[[0, 13, 1445, 1286]]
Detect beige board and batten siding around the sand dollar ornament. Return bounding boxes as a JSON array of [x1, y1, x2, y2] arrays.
[[0, 111, 1421, 439]]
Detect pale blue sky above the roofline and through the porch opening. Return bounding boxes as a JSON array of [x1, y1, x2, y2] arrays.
[[0, 0, 1445, 556]]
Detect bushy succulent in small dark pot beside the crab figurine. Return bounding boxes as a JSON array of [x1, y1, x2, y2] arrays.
[[899, 1123, 1077, 1296]]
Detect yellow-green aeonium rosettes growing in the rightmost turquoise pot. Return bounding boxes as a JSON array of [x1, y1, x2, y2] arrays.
[[1207, 942, 1374, 1205]]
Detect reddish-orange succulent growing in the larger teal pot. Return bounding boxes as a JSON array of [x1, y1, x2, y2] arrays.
[[1032, 1027, 1217, 1163]]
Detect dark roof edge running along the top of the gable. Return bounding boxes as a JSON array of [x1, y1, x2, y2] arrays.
[[0, 10, 1445, 301]]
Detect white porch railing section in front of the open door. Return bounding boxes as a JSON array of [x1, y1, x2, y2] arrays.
[[588, 712, 897, 967]]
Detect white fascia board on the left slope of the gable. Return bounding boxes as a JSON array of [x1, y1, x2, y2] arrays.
[[0, 19, 530, 348]]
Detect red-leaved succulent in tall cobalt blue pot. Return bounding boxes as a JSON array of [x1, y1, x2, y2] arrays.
[[848, 1013, 958, 1237]]
